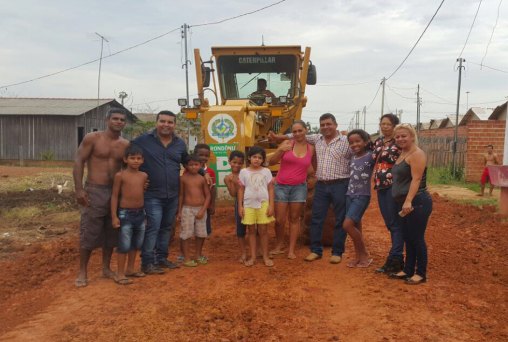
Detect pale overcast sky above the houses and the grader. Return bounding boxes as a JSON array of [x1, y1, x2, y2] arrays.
[[0, 0, 508, 132]]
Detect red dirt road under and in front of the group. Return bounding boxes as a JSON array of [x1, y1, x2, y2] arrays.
[[0, 196, 508, 341]]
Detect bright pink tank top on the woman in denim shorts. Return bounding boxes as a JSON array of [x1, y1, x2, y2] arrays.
[[276, 144, 312, 185]]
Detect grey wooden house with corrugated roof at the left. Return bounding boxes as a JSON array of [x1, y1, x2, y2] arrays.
[[0, 98, 136, 160]]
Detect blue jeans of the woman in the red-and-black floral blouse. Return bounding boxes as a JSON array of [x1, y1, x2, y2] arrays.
[[377, 187, 404, 261]]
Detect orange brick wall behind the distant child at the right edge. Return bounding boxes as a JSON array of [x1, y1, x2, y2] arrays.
[[465, 120, 506, 182]]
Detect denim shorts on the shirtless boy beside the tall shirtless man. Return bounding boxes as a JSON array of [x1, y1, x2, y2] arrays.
[[118, 208, 145, 253]]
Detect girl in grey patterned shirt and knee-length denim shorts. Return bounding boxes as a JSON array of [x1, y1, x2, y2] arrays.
[[343, 129, 375, 267]]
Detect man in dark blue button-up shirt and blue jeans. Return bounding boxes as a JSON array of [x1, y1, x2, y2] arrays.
[[133, 111, 188, 274]]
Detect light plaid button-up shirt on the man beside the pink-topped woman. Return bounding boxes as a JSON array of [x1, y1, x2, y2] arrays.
[[307, 133, 353, 181]]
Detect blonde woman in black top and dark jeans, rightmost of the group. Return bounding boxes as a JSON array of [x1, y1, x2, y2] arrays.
[[390, 124, 432, 285]]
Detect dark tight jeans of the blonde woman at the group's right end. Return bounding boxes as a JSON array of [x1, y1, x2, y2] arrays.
[[398, 191, 432, 278]]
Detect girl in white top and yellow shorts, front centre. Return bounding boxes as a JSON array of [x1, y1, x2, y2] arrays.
[[238, 146, 275, 266]]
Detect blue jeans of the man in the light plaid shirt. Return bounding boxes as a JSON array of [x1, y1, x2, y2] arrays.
[[310, 179, 349, 256]]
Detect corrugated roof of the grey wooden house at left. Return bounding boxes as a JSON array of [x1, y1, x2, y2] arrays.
[[0, 97, 114, 116]]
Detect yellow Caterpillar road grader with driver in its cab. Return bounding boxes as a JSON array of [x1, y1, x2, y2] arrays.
[[179, 46, 316, 197]]
